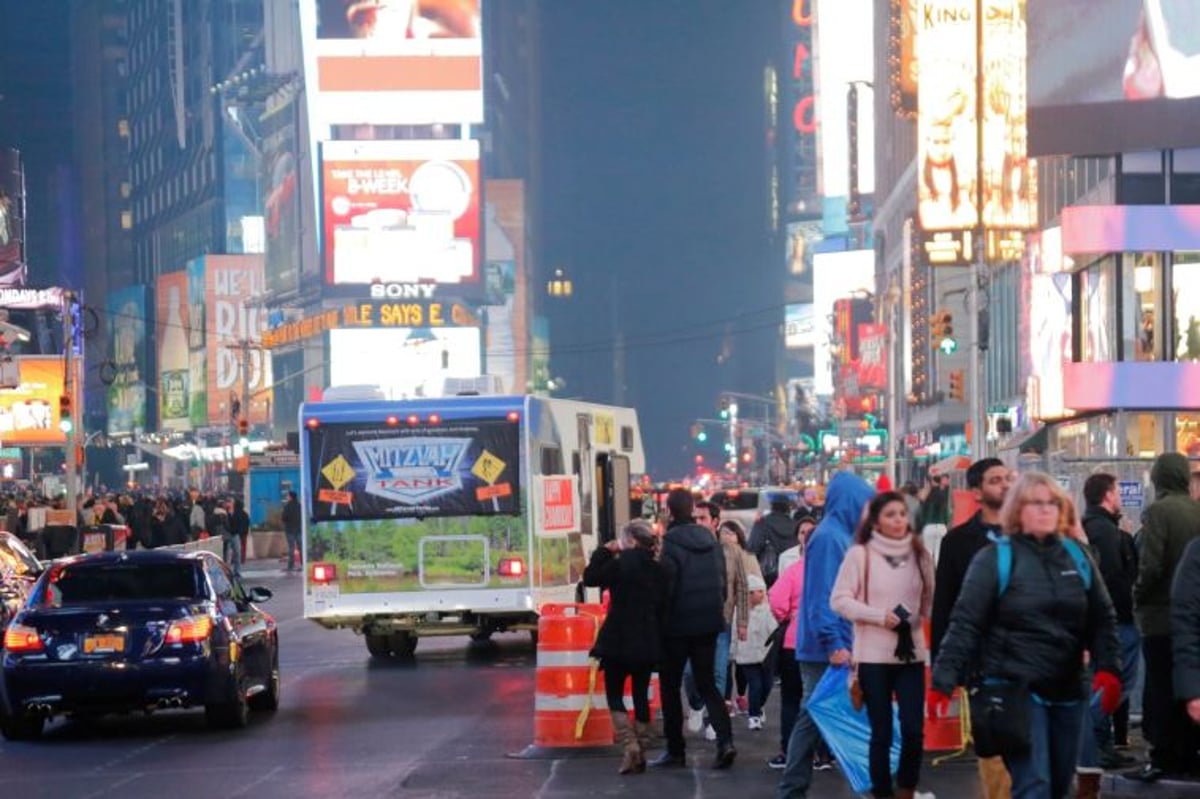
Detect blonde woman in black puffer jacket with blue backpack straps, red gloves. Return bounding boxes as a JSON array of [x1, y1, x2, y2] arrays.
[[930, 471, 1121, 799]]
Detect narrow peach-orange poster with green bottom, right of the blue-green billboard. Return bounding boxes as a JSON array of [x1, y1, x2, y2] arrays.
[[154, 271, 192, 431]]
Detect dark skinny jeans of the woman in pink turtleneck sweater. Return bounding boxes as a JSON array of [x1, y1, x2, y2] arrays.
[[858, 663, 925, 797]]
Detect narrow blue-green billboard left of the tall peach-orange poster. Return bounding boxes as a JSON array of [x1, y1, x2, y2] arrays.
[[108, 286, 150, 435]]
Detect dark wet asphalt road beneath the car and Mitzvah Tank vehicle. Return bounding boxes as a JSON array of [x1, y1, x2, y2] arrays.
[[0, 564, 977, 799]]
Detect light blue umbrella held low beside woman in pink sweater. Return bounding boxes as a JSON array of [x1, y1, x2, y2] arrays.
[[805, 666, 900, 793]]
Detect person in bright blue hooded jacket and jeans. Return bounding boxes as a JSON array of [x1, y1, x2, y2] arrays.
[[778, 471, 875, 799]]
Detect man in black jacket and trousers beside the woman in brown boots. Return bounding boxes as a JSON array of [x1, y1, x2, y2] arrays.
[[652, 488, 737, 769]]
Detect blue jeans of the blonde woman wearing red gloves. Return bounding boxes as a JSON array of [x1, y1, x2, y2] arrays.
[[1004, 698, 1086, 799]]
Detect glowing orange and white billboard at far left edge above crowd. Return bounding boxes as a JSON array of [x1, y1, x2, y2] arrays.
[[0, 355, 66, 446]]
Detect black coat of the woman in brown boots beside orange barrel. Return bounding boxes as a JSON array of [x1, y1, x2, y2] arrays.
[[583, 547, 667, 667]]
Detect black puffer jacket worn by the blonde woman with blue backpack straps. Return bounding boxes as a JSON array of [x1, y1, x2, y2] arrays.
[[934, 534, 1121, 702]]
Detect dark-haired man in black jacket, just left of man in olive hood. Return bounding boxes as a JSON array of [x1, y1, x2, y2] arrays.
[[1082, 473, 1141, 769]]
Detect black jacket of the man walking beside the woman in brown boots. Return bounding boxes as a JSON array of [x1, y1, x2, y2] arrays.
[[661, 522, 725, 637]]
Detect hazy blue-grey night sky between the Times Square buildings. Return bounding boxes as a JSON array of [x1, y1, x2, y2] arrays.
[[541, 0, 782, 479]]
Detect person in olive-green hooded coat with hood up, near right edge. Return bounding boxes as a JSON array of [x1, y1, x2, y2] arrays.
[[1128, 452, 1200, 782]]
